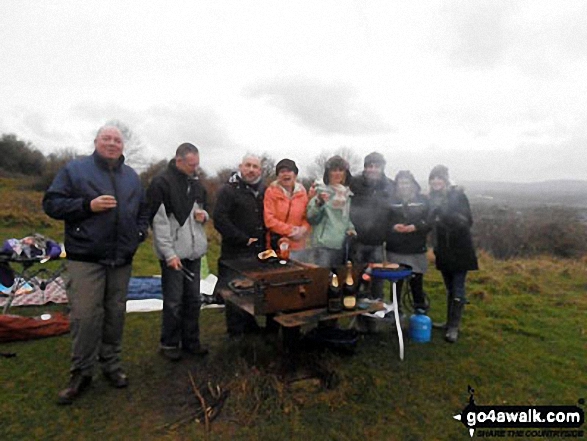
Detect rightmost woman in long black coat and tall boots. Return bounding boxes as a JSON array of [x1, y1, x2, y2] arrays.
[[428, 165, 479, 343]]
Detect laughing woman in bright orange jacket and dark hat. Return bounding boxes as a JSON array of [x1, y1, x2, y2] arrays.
[[263, 159, 310, 260]]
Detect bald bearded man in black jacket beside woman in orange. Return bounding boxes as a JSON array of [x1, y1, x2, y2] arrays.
[[213, 155, 265, 336]]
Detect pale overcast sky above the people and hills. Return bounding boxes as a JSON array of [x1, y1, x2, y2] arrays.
[[0, 0, 587, 182]]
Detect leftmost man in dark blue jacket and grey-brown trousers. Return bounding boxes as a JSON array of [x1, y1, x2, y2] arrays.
[[43, 126, 149, 404]]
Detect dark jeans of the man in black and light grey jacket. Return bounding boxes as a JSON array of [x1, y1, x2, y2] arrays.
[[159, 259, 201, 350]]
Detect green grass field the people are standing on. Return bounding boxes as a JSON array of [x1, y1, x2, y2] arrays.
[[0, 177, 587, 440]]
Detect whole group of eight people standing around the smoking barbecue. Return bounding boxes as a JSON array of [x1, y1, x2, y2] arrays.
[[43, 126, 477, 404]]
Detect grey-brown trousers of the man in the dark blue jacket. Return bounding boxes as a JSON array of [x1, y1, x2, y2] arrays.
[[67, 261, 131, 375]]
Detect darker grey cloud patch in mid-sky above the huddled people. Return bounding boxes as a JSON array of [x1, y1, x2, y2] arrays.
[[245, 78, 392, 135]]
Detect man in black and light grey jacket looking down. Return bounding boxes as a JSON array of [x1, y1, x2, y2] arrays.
[[147, 143, 209, 360]]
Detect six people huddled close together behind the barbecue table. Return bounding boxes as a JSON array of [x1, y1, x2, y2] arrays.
[[213, 148, 477, 342]]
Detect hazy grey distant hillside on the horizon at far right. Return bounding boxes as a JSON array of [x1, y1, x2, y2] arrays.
[[459, 180, 587, 208]]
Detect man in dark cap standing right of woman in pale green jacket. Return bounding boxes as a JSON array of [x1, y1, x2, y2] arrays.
[[350, 152, 395, 298]]
